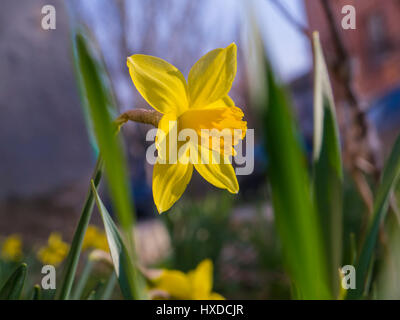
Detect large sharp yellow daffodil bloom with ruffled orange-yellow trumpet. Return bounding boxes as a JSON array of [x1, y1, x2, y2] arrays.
[[127, 43, 247, 213]]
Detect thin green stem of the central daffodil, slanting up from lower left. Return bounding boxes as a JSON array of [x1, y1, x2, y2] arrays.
[[57, 158, 102, 300]]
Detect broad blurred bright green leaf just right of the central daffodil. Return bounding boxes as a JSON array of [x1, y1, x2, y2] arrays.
[[264, 60, 332, 299]]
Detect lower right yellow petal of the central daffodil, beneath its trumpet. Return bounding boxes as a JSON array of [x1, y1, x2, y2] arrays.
[[190, 145, 239, 193]]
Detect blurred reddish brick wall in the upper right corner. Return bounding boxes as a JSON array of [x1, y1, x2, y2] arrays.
[[304, 0, 400, 102]]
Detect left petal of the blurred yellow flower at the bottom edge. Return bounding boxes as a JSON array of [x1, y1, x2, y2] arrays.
[[154, 270, 191, 300]]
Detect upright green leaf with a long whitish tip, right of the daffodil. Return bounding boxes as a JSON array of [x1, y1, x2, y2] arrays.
[[313, 32, 343, 296]]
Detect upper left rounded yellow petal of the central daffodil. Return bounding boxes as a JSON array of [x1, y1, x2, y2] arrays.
[[127, 54, 188, 115]]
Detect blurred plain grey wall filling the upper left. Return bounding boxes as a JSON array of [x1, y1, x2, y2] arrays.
[[0, 0, 92, 200]]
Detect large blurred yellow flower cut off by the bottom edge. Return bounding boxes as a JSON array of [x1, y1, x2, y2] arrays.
[[152, 259, 225, 300]]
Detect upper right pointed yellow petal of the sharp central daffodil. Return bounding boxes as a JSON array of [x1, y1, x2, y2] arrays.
[[188, 43, 237, 108]]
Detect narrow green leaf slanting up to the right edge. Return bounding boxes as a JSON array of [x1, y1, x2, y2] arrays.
[[347, 136, 400, 299]]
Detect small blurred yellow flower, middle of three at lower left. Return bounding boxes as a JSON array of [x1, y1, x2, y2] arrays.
[[37, 232, 69, 266]]
